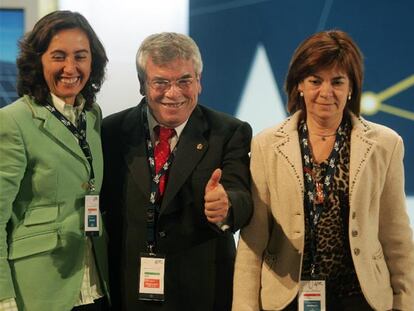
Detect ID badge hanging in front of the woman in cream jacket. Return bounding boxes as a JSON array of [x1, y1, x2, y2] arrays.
[[298, 280, 326, 311]]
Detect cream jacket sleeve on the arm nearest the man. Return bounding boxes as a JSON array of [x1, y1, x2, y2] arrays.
[[233, 139, 271, 311]]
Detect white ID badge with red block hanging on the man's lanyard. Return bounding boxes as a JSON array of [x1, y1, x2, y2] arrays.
[[138, 253, 165, 301]]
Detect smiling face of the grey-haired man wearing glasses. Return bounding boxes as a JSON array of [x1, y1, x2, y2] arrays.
[[145, 57, 201, 128]]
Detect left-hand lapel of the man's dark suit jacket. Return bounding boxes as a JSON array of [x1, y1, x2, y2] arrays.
[[122, 101, 151, 196]]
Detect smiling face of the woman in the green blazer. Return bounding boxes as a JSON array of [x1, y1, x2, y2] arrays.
[[42, 28, 92, 105]]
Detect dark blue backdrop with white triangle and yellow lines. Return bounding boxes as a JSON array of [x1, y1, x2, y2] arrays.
[[190, 0, 414, 196]]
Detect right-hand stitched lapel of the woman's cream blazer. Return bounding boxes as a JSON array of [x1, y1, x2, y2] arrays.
[[349, 114, 376, 201]]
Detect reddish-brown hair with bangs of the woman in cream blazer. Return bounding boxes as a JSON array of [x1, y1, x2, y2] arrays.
[[285, 30, 364, 115]]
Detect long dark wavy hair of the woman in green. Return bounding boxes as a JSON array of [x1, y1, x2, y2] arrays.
[[17, 11, 108, 109]]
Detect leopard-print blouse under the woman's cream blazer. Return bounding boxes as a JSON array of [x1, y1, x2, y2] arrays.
[[299, 118, 361, 298]]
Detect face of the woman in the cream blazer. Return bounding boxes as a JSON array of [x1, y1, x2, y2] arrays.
[[298, 68, 351, 121]]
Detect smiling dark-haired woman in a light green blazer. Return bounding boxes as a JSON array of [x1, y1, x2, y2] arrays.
[[0, 11, 109, 311]]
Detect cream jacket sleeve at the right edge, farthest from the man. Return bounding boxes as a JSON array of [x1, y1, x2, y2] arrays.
[[379, 137, 414, 310]]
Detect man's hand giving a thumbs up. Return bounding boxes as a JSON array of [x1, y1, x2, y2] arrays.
[[204, 168, 229, 224]]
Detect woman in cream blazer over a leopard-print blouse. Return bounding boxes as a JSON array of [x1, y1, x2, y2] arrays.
[[233, 31, 414, 311]]
